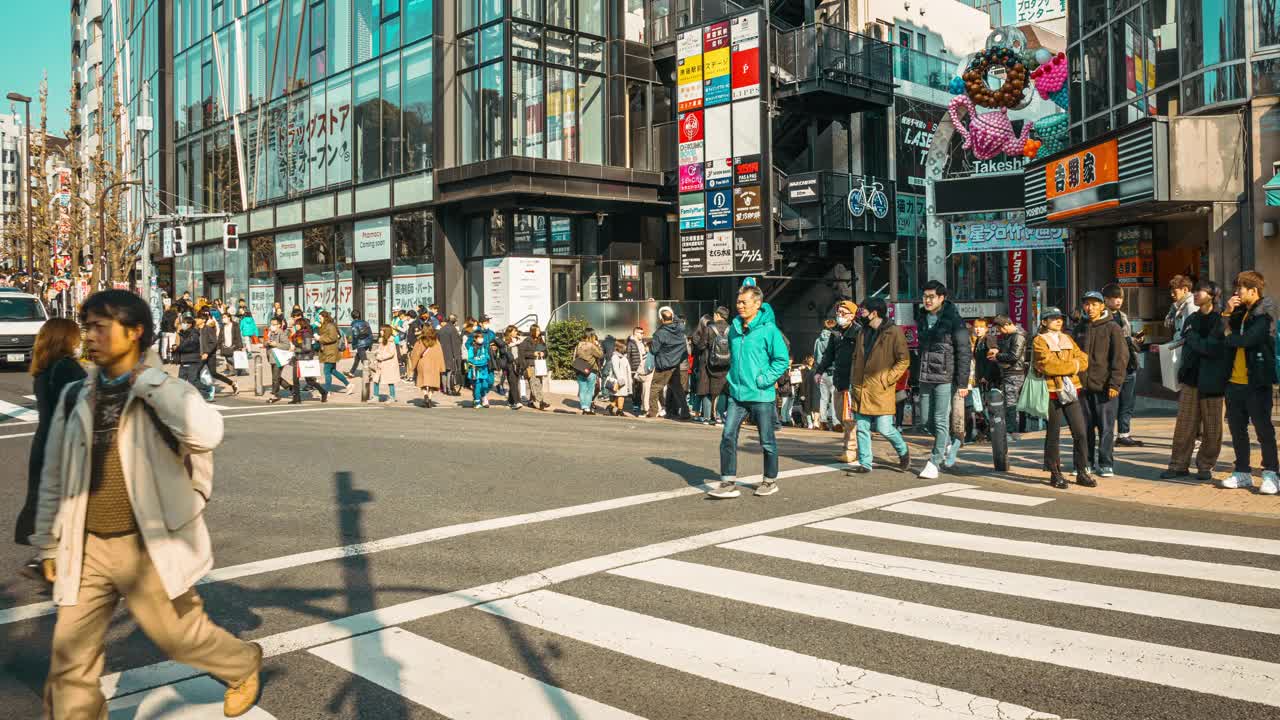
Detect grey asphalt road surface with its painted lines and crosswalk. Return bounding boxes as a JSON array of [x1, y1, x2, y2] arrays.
[[0, 363, 1280, 720]]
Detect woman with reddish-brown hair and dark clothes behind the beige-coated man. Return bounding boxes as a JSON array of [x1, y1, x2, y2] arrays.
[[13, 318, 87, 578]]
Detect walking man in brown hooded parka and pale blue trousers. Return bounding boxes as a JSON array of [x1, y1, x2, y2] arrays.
[[845, 297, 911, 473]]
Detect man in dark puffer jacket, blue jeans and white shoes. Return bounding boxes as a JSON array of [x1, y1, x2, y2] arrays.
[[915, 281, 973, 480]]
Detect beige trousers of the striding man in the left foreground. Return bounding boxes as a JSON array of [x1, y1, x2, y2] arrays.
[[45, 533, 257, 720]]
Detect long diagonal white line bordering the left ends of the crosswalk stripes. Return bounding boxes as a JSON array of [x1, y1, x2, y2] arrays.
[[101, 483, 969, 697]]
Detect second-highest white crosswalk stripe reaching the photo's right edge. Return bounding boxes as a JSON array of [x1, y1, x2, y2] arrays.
[[812, 518, 1280, 589]]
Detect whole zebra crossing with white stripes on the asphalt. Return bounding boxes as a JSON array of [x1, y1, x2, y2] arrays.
[[92, 486, 1280, 720]]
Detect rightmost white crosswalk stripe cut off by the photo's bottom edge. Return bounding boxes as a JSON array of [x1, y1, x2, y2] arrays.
[[479, 591, 1057, 720]]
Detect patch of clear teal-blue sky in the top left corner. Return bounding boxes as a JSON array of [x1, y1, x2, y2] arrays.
[[0, 0, 72, 135]]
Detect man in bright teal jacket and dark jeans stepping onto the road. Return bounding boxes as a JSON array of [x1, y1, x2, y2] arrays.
[[708, 284, 791, 498]]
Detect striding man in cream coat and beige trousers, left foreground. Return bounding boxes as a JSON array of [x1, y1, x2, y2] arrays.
[[31, 290, 262, 720]]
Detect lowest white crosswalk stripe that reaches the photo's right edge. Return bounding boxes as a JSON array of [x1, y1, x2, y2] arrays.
[[609, 559, 1280, 707]]
